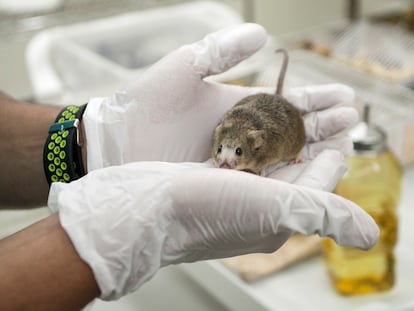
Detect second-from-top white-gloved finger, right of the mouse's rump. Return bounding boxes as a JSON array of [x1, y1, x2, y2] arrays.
[[303, 107, 358, 142]]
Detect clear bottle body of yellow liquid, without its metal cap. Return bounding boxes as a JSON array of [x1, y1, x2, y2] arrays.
[[323, 151, 401, 295]]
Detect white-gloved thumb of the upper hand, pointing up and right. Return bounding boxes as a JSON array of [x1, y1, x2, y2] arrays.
[[188, 23, 268, 78]]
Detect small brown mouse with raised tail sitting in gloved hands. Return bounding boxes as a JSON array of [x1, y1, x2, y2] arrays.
[[212, 49, 306, 175]]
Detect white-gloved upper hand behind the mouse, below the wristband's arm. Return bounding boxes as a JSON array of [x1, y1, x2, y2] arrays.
[[84, 24, 356, 171]]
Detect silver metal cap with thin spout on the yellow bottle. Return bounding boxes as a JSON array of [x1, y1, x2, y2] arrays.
[[348, 104, 387, 153]]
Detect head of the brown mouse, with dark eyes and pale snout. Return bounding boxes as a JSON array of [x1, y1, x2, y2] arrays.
[[212, 121, 265, 174]]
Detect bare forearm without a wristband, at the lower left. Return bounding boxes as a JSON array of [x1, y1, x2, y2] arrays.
[[0, 215, 99, 310]]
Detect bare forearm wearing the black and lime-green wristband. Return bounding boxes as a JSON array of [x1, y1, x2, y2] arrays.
[[0, 92, 62, 207]]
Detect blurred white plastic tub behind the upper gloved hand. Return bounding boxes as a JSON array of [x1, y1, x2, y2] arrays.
[[26, 1, 243, 105]]
